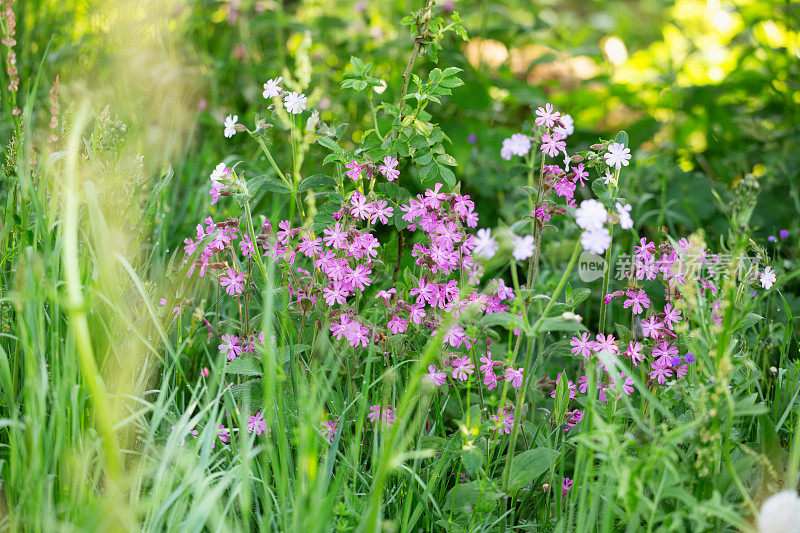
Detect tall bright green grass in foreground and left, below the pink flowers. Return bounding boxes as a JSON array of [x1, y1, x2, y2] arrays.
[[0, 2, 800, 532]]
